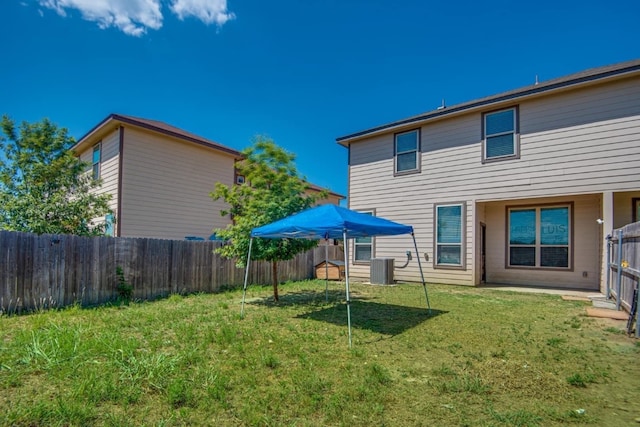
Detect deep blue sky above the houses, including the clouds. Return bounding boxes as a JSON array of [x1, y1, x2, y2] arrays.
[[0, 0, 640, 195]]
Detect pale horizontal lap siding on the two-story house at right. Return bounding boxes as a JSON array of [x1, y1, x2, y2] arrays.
[[349, 77, 640, 286]]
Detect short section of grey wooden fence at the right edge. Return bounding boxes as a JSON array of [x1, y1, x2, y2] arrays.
[[606, 222, 640, 337]]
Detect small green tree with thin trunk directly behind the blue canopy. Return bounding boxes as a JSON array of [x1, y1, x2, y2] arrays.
[[211, 137, 327, 301]]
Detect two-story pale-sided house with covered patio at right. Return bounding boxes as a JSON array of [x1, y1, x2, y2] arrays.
[[337, 60, 640, 290]]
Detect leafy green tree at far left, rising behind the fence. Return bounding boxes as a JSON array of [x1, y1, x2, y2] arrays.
[[0, 115, 111, 235]]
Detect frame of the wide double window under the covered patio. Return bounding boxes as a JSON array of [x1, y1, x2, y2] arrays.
[[505, 203, 573, 271]]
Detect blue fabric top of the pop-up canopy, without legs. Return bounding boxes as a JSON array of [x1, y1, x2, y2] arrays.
[[251, 205, 413, 240]]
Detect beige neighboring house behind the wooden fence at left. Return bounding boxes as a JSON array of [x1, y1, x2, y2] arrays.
[[73, 114, 344, 239]]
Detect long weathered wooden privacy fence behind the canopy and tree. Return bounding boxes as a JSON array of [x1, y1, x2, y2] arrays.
[[0, 231, 342, 313]]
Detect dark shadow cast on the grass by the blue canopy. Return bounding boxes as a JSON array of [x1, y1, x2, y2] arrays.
[[296, 300, 447, 335]]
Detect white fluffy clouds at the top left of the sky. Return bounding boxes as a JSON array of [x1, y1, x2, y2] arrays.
[[38, 0, 235, 36]]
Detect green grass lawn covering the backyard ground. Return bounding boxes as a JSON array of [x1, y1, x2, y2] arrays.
[[0, 281, 640, 426]]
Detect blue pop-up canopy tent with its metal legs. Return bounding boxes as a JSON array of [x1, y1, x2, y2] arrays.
[[241, 205, 431, 347]]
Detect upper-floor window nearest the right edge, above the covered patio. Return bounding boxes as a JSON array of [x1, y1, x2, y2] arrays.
[[482, 107, 520, 162]]
